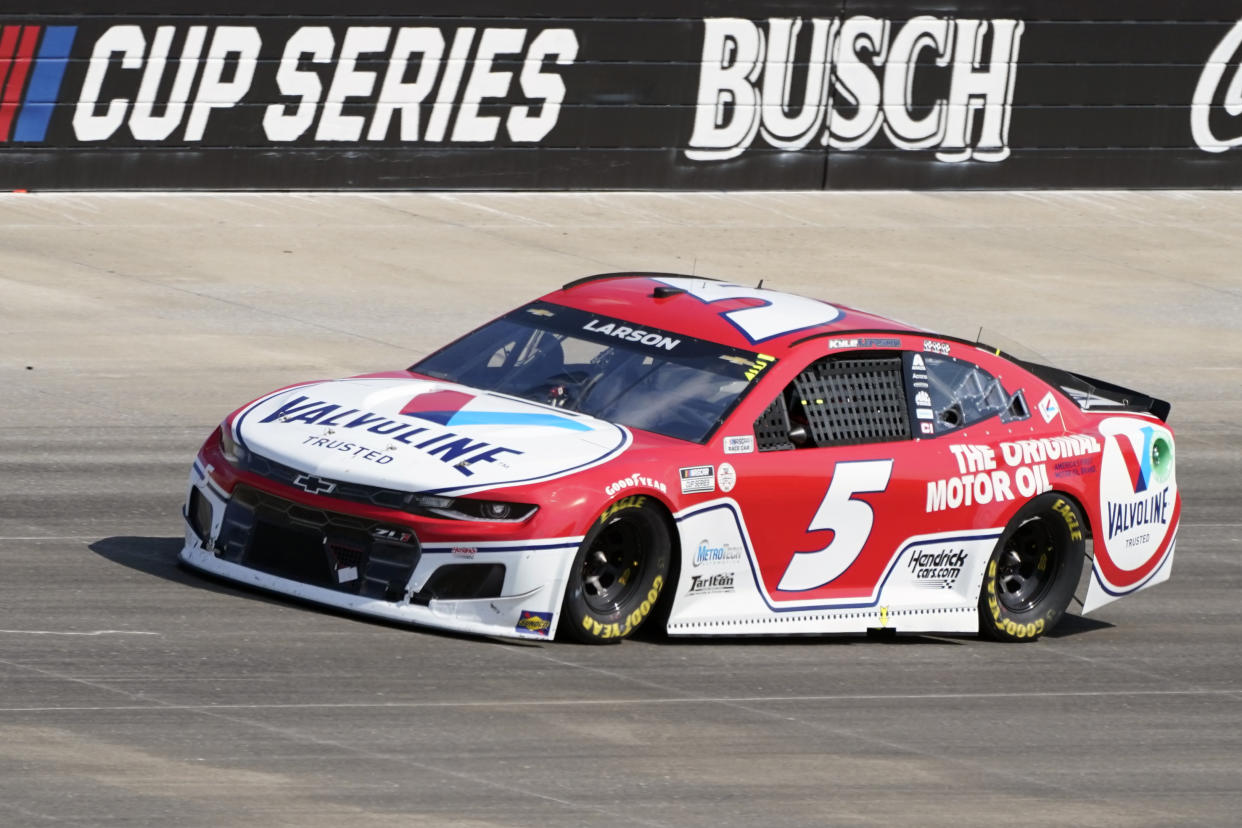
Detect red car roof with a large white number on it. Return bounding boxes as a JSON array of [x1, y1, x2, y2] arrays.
[[543, 273, 920, 356]]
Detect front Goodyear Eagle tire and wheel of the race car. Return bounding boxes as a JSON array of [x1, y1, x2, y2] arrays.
[[559, 495, 673, 644]]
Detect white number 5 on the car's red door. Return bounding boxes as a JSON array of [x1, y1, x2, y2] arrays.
[[777, 461, 893, 592]]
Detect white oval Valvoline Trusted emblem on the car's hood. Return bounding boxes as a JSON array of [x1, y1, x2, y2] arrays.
[[232, 377, 632, 494]]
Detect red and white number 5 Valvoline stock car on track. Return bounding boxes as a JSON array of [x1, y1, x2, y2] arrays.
[[181, 273, 1181, 642]]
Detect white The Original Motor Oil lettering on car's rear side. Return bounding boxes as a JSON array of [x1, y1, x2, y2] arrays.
[[927, 434, 1100, 513]]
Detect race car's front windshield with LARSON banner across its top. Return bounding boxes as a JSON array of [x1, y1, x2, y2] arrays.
[[410, 302, 775, 442]]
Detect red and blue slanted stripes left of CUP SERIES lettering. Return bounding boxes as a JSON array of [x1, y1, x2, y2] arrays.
[[0, 25, 77, 142]]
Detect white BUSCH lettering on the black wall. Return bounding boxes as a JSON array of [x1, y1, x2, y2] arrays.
[[686, 16, 1023, 161]]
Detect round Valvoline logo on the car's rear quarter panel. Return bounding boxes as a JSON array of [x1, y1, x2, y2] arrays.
[[1095, 417, 1181, 595]]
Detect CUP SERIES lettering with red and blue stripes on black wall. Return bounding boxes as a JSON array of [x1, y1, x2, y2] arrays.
[[0, 20, 578, 145]]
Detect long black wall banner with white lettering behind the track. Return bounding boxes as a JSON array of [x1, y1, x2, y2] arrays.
[[0, 0, 1242, 190]]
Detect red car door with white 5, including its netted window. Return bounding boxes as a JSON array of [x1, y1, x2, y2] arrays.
[[730, 351, 925, 608]]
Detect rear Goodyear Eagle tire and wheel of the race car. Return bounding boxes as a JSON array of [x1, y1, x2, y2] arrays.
[[979, 492, 1087, 641]]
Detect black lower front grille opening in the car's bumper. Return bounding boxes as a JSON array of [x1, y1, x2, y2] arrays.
[[216, 485, 421, 601]]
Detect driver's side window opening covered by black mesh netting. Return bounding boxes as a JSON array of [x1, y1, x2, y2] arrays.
[[755, 353, 910, 452]]
